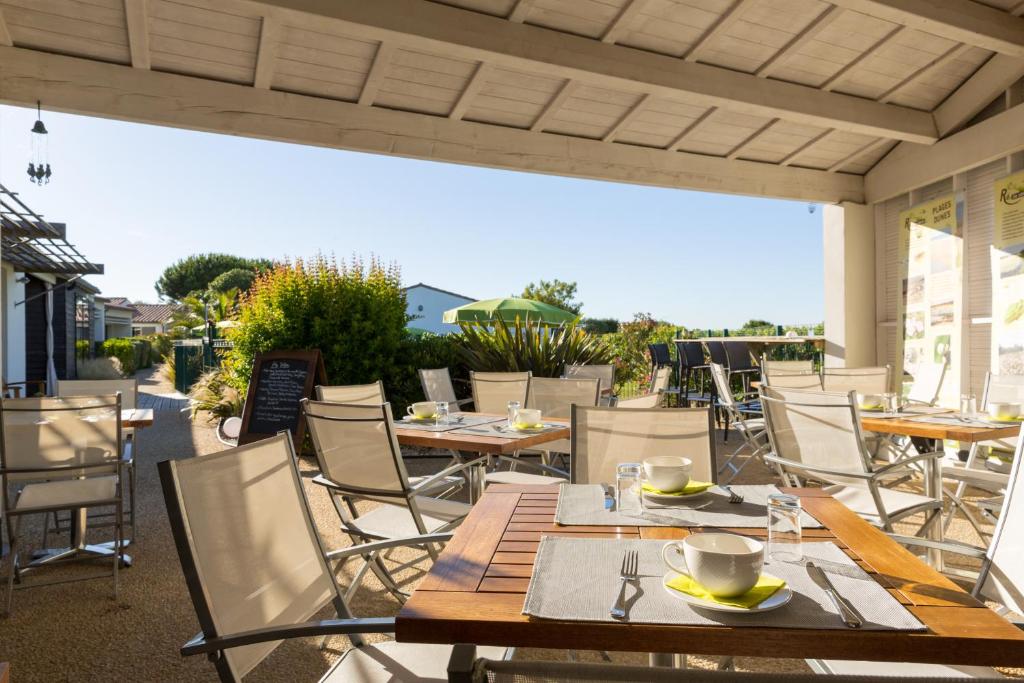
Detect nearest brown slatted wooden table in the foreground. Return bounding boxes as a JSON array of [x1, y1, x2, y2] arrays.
[[395, 484, 1024, 667]]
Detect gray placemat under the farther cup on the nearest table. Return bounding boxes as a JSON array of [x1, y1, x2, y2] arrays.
[[555, 484, 822, 528]]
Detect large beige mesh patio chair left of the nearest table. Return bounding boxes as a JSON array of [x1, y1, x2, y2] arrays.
[[158, 433, 503, 683]]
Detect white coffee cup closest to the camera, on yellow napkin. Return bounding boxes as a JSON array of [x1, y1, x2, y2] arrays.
[[662, 533, 765, 598]]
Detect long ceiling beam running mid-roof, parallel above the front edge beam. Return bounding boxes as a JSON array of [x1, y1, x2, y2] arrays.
[[245, 0, 936, 144]]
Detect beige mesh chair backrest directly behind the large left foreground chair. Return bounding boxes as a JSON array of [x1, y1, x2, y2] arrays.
[[302, 399, 409, 502]]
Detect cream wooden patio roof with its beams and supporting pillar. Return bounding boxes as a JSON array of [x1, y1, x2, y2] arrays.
[[0, 0, 1024, 374]]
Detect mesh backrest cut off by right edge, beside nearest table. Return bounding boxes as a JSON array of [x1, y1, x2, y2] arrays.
[[979, 430, 1024, 614]]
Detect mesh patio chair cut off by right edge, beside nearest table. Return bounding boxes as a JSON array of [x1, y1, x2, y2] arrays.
[[808, 432, 1024, 680]]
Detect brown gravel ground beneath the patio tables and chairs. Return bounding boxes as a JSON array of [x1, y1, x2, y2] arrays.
[[0, 373, 1009, 683]]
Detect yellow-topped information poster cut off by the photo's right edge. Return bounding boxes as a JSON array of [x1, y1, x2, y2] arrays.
[[992, 172, 1024, 375]]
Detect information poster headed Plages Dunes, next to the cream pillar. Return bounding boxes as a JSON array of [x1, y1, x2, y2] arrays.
[[896, 194, 964, 405]]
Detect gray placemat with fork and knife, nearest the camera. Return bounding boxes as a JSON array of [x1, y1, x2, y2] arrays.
[[522, 537, 926, 631]]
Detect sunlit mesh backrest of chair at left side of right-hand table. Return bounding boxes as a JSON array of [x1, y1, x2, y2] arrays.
[[761, 385, 870, 483]]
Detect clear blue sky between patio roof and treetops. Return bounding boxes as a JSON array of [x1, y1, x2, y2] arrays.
[[0, 106, 824, 328]]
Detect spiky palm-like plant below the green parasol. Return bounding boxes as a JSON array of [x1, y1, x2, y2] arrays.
[[456, 317, 614, 377]]
